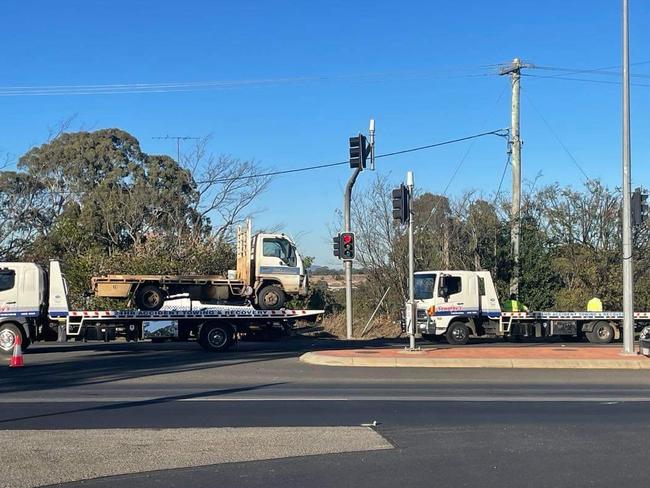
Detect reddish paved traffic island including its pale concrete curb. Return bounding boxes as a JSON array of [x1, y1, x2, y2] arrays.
[[300, 346, 650, 369]]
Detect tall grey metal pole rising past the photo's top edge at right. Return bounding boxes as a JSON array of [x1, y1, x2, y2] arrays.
[[622, 0, 634, 354]]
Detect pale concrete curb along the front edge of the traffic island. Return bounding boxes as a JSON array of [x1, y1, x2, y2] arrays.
[[300, 352, 650, 369]]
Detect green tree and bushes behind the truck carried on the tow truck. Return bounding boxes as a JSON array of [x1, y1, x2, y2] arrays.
[[0, 129, 266, 308]]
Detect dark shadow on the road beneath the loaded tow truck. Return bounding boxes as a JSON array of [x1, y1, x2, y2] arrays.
[[0, 337, 402, 394]]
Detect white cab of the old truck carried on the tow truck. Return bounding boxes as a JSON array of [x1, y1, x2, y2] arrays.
[[258, 236, 300, 293]]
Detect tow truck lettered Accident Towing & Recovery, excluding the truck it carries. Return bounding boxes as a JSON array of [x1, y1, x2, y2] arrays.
[[0, 261, 323, 354]]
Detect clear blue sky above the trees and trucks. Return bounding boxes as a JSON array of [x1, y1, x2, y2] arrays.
[[0, 0, 650, 265]]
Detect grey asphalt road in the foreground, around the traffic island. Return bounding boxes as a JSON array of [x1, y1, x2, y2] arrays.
[[0, 338, 650, 487]]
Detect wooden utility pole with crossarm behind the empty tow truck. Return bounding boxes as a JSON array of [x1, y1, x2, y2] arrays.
[[499, 58, 532, 298]]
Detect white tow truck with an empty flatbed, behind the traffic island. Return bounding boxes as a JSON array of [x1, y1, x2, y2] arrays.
[[415, 270, 650, 344]]
